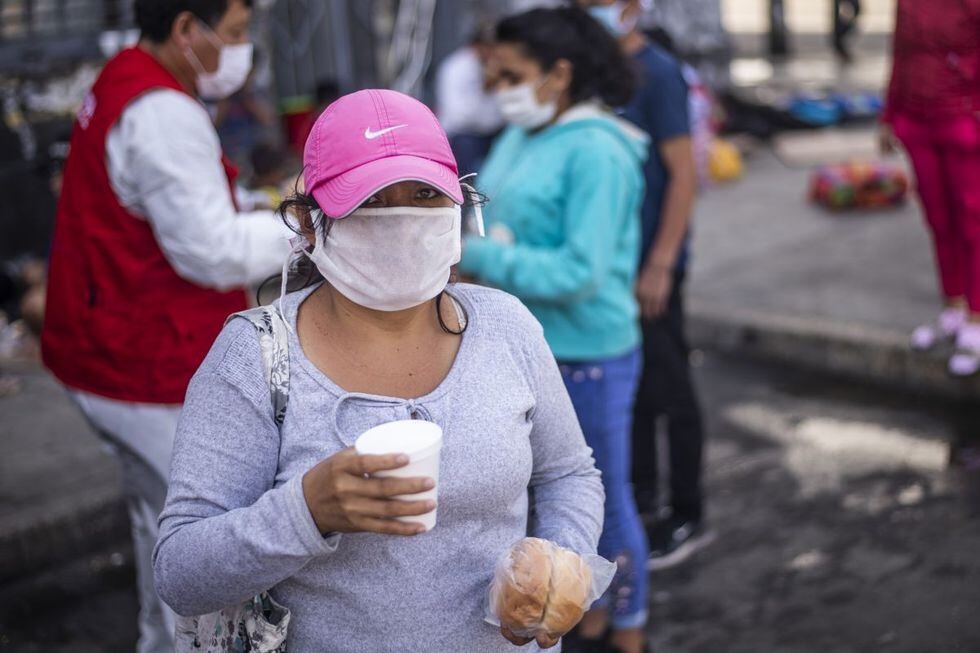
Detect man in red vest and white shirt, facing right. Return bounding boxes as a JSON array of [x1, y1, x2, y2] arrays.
[[42, 0, 291, 653]]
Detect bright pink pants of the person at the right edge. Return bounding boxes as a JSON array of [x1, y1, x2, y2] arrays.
[[892, 114, 980, 313]]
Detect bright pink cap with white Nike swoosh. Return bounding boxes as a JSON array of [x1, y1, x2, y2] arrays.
[[303, 89, 463, 218]]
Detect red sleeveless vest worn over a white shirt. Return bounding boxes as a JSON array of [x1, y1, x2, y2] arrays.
[[41, 48, 247, 404]]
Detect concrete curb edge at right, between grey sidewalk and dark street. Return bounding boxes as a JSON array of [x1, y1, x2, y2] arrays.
[[688, 302, 980, 401]]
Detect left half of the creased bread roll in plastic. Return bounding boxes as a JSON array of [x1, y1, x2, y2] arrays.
[[497, 538, 552, 634]]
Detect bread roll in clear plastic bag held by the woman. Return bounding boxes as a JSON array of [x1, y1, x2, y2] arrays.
[[486, 537, 616, 637]]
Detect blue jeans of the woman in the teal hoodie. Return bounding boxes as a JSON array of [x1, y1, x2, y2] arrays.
[[559, 349, 649, 630]]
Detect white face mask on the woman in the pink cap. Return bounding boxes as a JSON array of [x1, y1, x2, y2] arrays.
[[309, 206, 462, 311]]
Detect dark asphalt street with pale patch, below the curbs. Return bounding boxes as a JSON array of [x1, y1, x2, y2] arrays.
[[0, 354, 980, 653]]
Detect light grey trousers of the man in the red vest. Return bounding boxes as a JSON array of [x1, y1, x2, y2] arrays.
[[72, 392, 180, 653]]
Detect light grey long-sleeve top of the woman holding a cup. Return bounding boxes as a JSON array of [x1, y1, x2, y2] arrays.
[[153, 285, 603, 653]]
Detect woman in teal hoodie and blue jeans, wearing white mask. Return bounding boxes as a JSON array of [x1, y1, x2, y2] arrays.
[[460, 8, 648, 653]]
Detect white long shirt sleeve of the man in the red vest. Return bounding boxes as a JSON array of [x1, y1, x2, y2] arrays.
[[106, 89, 294, 290]]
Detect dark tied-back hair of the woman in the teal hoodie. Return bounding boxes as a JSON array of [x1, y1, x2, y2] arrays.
[[497, 7, 636, 107]]
